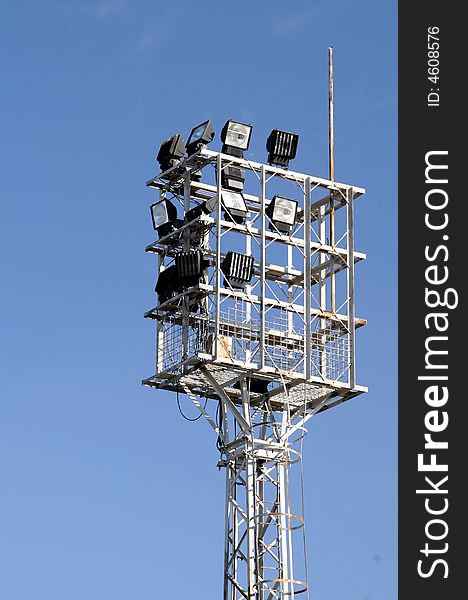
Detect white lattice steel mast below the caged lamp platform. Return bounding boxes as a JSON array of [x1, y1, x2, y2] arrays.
[[220, 381, 322, 600]]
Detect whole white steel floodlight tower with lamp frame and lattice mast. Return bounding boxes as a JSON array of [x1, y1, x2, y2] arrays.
[[143, 112, 367, 600]]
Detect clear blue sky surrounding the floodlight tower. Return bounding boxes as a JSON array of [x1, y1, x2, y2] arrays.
[[0, 0, 397, 600]]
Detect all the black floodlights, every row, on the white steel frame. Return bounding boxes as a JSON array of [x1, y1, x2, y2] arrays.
[[150, 120, 299, 310]]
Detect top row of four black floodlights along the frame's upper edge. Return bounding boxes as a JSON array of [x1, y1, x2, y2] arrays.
[[157, 119, 299, 172]]
